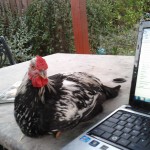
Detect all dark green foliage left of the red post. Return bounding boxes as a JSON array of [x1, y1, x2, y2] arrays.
[[0, 0, 74, 62]]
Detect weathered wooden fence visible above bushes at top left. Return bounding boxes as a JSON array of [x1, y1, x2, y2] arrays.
[[0, 0, 32, 14]]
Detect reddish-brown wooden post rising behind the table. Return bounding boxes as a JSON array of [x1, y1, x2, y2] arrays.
[[71, 0, 90, 54]]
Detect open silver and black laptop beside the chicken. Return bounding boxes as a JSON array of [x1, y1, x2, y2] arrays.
[[62, 21, 150, 150]]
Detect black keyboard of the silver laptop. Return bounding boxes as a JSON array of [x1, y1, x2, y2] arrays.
[[89, 111, 150, 150]]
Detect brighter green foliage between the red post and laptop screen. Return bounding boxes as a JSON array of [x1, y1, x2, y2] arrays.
[[87, 0, 150, 55]]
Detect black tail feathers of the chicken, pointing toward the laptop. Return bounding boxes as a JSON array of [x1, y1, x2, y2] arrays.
[[102, 85, 121, 99]]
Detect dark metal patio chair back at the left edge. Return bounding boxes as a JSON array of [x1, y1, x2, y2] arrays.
[[0, 36, 15, 68]]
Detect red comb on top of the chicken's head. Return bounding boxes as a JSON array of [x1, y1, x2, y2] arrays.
[[36, 56, 48, 70]]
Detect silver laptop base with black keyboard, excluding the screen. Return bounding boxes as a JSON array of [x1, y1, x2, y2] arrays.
[[62, 105, 150, 150]]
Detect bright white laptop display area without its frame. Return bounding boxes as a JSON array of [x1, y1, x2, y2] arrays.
[[134, 28, 150, 103]]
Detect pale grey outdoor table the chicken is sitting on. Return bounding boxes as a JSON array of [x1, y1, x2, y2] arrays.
[[0, 53, 134, 150]]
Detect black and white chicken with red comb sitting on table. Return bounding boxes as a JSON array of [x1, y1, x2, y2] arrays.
[[14, 56, 120, 137]]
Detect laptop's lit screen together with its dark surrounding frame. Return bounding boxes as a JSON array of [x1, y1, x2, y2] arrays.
[[129, 21, 150, 110]]
